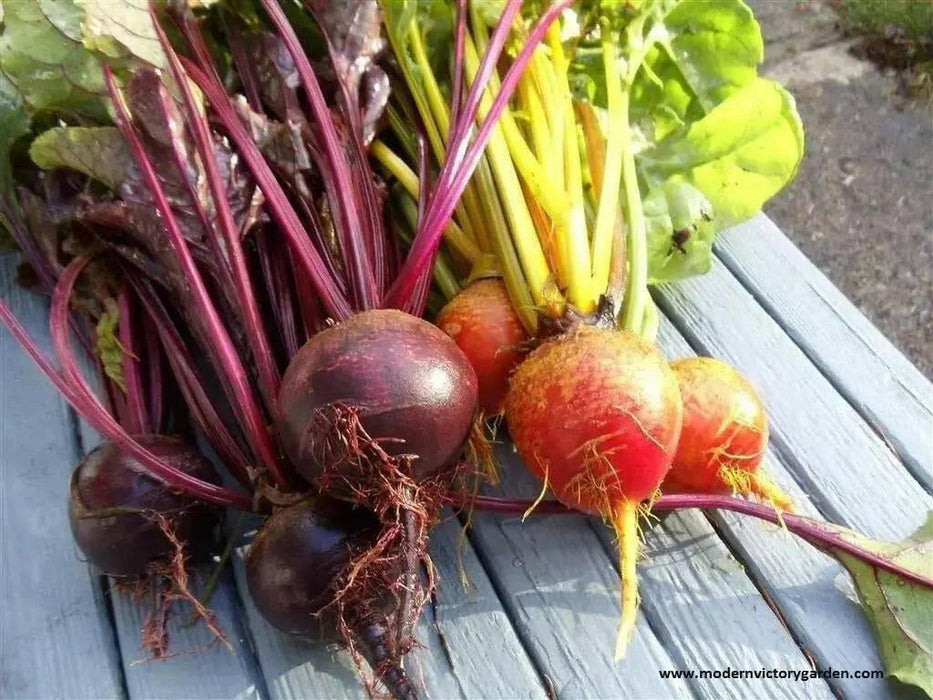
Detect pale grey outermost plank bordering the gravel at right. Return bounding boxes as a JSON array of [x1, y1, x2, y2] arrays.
[[716, 215, 933, 490]]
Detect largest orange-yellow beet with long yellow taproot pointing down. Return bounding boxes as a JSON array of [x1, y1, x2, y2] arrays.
[[505, 327, 682, 658]]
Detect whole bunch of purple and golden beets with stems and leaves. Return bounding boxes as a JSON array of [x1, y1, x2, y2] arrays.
[[0, 0, 933, 698]]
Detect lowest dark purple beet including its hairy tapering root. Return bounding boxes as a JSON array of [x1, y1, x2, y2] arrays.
[[246, 498, 417, 700]]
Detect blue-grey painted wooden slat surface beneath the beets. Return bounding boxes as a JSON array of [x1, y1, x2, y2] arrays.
[[0, 216, 933, 700]]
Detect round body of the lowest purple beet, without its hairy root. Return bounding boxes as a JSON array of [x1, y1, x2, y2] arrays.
[[246, 499, 377, 642]]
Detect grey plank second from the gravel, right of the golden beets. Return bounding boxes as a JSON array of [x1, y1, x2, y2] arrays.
[[658, 260, 931, 539]]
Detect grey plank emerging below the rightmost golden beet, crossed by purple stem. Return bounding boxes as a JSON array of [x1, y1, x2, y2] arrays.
[[659, 319, 916, 699]]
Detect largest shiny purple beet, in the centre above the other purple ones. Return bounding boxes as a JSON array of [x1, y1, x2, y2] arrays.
[[277, 310, 478, 482]]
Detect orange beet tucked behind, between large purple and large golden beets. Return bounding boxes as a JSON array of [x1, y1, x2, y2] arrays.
[[436, 279, 528, 416]]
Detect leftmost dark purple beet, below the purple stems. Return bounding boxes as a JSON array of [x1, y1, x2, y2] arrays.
[[68, 435, 220, 576]]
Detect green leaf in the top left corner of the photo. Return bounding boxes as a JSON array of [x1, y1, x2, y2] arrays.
[[0, 0, 107, 121]]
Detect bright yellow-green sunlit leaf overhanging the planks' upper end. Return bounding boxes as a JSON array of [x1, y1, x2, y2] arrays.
[[638, 78, 804, 227]]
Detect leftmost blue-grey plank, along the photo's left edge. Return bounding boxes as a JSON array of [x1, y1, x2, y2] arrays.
[[0, 255, 124, 698]]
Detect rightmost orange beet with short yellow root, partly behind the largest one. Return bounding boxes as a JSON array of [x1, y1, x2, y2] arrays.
[[664, 357, 793, 511]]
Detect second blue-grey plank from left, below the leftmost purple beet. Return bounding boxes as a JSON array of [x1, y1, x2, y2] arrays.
[[79, 416, 263, 700]]
